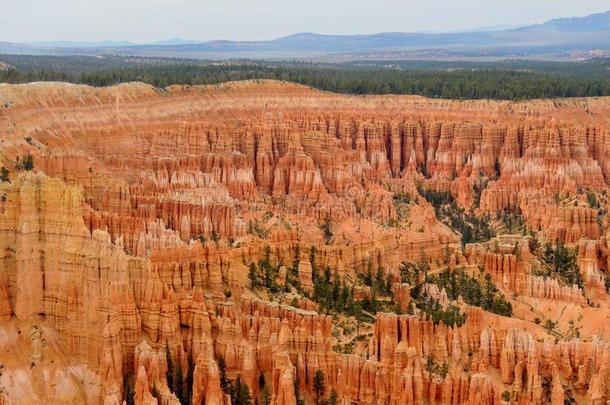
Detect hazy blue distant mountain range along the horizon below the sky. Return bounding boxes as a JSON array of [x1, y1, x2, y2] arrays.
[[0, 11, 610, 59]]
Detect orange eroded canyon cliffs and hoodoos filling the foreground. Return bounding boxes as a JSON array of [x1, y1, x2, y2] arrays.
[[0, 82, 610, 405]]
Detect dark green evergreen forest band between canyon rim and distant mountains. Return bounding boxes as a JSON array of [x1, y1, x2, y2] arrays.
[[0, 55, 610, 100]]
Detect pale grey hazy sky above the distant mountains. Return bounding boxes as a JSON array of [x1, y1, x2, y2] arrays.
[[0, 0, 610, 42]]
